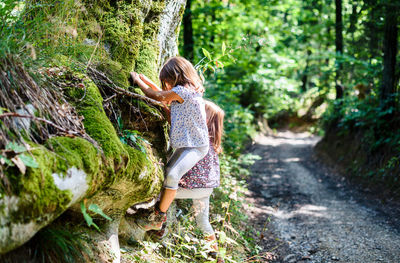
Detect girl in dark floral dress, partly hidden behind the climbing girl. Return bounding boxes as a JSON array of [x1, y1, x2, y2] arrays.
[[175, 101, 225, 262]]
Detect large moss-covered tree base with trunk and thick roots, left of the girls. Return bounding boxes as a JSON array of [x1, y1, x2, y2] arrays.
[[0, 0, 186, 262]]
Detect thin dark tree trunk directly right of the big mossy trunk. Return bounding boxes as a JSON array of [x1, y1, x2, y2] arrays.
[[183, 0, 194, 61]]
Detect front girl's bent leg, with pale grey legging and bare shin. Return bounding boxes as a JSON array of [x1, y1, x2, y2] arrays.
[[159, 146, 208, 212]]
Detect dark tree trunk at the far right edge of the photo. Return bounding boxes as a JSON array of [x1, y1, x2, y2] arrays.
[[380, 3, 398, 108]]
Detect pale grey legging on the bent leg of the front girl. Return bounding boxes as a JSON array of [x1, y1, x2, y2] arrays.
[[164, 145, 208, 190]]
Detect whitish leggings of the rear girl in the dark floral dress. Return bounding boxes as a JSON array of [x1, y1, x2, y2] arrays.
[[175, 188, 214, 236]]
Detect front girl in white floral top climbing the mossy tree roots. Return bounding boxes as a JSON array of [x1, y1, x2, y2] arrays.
[[131, 57, 209, 231]]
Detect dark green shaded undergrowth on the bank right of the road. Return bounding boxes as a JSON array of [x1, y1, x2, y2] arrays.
[[322, 94, 400, 193]]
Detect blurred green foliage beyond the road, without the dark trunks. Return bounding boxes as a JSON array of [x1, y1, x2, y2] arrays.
[[180, 0, 400, 186]]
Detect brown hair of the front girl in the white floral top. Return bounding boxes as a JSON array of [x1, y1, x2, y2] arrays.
[[159, 57, 204, 93]]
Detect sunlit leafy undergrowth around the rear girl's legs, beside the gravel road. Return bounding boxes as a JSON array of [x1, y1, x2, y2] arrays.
[[122, 154, 261, 263]]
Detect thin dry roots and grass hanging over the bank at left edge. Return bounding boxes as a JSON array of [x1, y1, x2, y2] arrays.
[[0, 56, 96, 149]]
